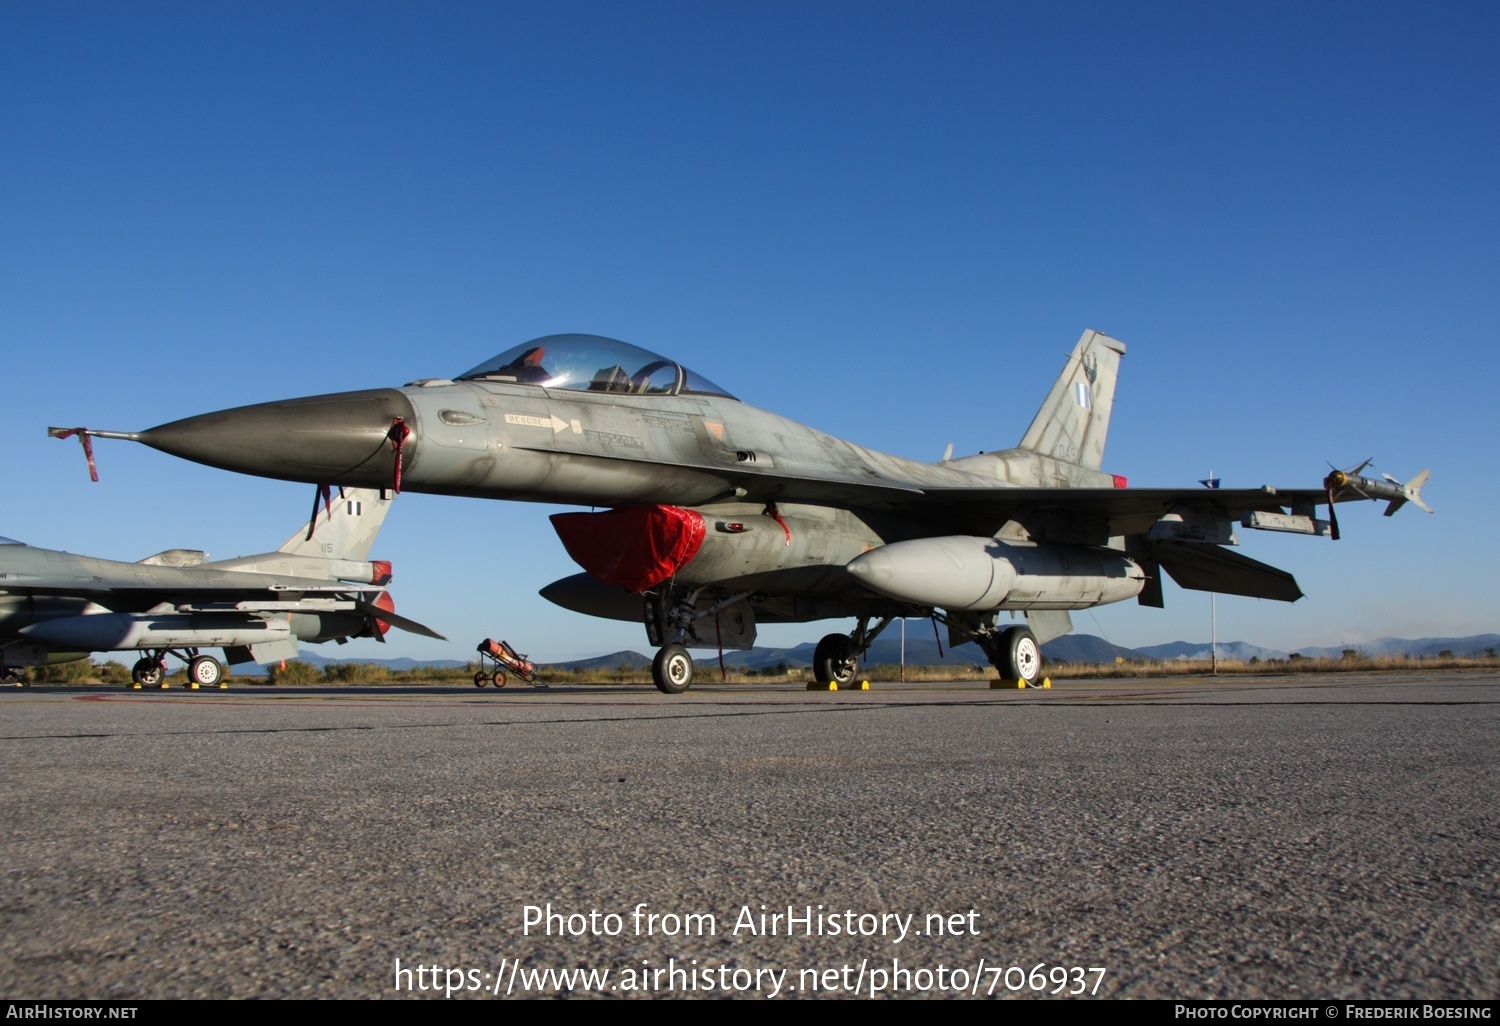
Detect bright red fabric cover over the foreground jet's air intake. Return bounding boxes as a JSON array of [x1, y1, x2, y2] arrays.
[[552, 506, 707, 594]]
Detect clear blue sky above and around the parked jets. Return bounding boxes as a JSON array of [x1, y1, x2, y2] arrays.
[[0, 0, 1500, 660]]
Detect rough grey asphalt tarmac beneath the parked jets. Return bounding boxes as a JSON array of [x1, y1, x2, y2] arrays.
[[0, 674, 1500, 1001]]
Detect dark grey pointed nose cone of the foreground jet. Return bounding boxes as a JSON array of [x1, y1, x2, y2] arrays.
[[140, 389, 417, 488]]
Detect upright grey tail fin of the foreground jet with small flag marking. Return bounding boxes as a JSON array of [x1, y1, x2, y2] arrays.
[[1020, 332, 1125, 470]]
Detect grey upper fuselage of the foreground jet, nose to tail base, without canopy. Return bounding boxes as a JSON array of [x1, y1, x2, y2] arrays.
[[140, 372, 1115, 507]]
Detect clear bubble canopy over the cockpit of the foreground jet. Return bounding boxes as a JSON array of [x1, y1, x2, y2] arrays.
[[458, 335, 735, 399]]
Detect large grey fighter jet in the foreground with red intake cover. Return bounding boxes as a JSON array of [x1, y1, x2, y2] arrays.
[[49, 332, 1427, 693]]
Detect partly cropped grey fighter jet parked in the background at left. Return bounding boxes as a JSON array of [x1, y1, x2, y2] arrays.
[[0, 489, 441, 687]]
